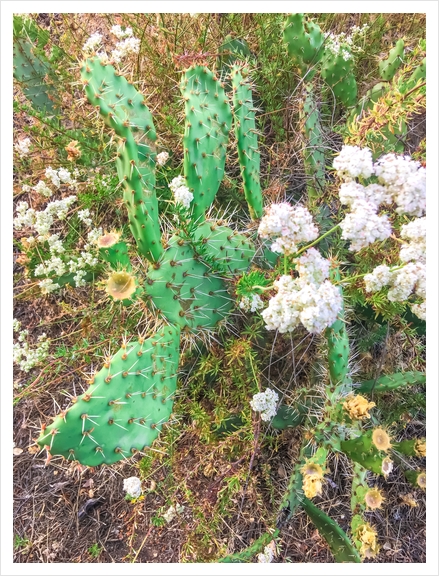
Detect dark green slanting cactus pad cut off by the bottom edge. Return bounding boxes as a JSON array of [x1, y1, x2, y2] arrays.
[[301, 497, 361, 562]]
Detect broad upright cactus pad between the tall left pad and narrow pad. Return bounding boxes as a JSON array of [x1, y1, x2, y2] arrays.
[[180, 66, 232, 220]]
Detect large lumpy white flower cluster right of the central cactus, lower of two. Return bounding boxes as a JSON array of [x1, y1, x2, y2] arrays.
[[262, 251, 342, 334]]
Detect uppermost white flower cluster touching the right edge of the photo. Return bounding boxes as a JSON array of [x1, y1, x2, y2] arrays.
[[375, 154, 426, 217]]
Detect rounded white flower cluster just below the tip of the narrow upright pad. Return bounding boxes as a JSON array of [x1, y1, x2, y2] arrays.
[[258, 202, 319, 254]]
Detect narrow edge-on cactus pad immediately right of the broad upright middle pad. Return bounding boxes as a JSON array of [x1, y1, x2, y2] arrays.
[[231, 64, 263, 220]]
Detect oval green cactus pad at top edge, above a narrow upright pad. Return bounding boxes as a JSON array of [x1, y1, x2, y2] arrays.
[[283, 13, 324, 80]]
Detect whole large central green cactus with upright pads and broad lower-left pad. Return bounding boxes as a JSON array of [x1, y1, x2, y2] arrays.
[[38, 56, 262, 466]]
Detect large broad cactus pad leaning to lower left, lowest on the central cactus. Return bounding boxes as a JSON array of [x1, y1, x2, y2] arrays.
[[38, 326, 180, 466]]
